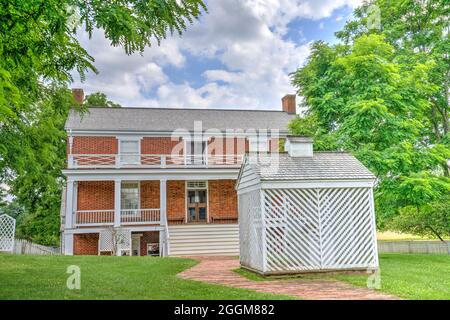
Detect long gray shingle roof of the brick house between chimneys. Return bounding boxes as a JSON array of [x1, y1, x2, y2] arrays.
[[66, 108, 294, 131]]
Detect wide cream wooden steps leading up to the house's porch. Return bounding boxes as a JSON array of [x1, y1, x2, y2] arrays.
[[169, 224, 239, 256]]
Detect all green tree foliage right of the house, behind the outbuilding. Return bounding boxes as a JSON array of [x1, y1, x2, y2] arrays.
[[290, 0, 450, 239]]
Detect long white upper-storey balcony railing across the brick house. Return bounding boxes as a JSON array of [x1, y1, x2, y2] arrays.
[[68, 154, 243, 169]]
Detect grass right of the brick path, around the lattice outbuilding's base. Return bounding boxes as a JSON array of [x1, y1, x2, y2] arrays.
[[234, 253, 450, 300]]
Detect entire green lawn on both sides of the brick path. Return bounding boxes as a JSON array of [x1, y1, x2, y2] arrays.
[[0, 254, 450, 299]]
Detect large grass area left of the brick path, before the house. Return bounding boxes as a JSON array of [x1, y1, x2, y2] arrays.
[[0, 254, 290, 300]]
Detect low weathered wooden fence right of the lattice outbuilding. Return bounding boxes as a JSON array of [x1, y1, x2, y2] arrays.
[[378, 240, 450, 254]]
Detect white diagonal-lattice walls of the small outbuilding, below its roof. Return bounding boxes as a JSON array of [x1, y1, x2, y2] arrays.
[[239, 188, 378, 273]]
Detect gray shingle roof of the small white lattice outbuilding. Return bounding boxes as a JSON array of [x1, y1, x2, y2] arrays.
[[250, 152, 375, 181]]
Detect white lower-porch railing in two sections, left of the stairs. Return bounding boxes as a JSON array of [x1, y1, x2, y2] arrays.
[[75, 209, 160, 227]]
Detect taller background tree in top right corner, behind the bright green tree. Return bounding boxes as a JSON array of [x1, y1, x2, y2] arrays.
[[337, 0, 450, 176]]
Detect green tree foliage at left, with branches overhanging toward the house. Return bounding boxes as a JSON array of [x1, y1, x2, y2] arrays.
[[0, 0, 206, 245]]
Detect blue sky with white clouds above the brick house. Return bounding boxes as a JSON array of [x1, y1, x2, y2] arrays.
[[73, 0, 362, 110]]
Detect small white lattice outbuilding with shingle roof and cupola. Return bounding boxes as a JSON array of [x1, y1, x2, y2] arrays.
[[236, 136, 378, 274]]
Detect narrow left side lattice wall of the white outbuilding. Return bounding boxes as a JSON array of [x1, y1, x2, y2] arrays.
[[239, 190, 263, 270]]
